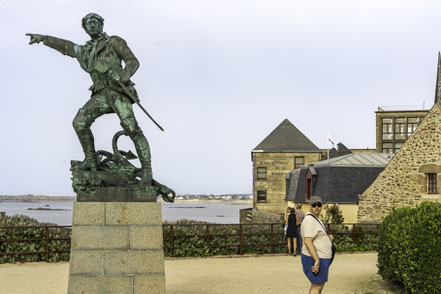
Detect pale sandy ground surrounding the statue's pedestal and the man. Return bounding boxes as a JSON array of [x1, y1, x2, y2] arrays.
[[0, 253, 388, 294]]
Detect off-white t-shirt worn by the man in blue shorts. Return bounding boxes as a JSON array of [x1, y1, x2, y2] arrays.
[[301, 212, 332, 258]]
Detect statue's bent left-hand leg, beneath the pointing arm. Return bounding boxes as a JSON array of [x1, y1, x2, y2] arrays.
[[72, 95, 111, 171]]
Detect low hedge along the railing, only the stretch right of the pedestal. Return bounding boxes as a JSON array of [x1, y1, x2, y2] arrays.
[[164, 220, 378, 257]]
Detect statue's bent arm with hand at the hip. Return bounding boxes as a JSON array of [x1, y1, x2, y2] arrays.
[[111, 36, 139, 82]]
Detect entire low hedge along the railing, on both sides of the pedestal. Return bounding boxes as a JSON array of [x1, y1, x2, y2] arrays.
[[0, 216, 376, 263]]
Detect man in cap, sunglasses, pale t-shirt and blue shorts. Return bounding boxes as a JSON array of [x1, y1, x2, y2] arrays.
[[301, 196, 333, 294]]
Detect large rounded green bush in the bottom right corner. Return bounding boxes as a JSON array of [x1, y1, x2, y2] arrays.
[[378, 203, 441, 293]]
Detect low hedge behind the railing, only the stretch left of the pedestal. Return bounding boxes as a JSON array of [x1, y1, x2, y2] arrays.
[[0, 215, 71, 264]]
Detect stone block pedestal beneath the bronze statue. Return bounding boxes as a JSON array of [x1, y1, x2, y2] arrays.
[[68, 202, 165, 294]]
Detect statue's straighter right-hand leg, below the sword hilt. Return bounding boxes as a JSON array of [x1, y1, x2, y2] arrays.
[[109, 91, 153, 186]]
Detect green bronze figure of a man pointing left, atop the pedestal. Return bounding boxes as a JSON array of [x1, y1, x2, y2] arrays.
[[27, 13, 152, 185]]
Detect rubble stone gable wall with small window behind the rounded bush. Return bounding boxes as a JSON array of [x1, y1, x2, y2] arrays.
[[358, 104, 441, 222]]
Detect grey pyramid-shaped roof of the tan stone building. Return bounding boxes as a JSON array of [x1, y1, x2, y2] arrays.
[[253, 119, 321, 152]]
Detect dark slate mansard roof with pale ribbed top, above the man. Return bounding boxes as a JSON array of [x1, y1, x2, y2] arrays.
[[285, 153, 391, 204]]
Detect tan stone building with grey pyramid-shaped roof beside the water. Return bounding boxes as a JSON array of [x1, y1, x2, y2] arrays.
[[251, 119, 322, 214]]
